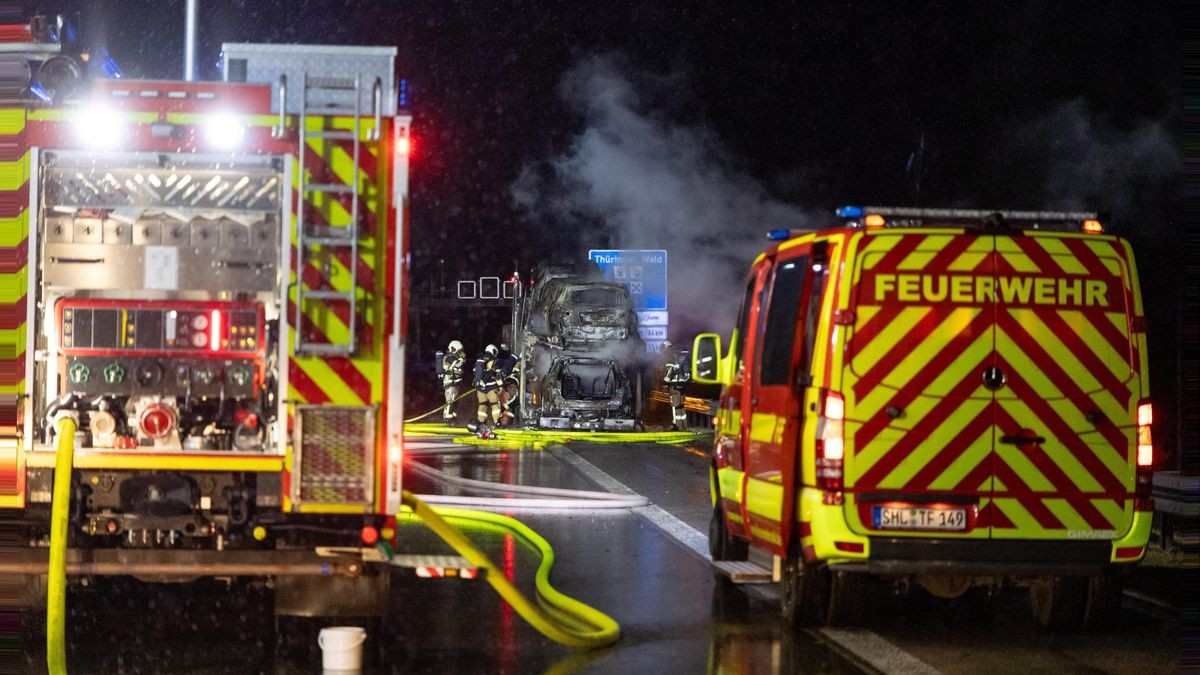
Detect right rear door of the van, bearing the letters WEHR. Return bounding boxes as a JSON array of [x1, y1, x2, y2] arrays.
[[991, 232, 1141, 539]]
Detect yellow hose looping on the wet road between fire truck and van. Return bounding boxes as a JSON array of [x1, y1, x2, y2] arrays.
[[400, 490, 620, 649]]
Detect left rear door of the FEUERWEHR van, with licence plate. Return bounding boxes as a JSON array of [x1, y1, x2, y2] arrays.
[[841, 229, 996, 538]]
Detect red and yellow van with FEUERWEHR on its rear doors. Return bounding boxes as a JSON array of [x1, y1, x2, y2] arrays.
[[692, 207, 1153, 628]]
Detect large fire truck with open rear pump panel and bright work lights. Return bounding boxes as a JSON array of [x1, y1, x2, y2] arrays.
[[0, 26, 420, 613]]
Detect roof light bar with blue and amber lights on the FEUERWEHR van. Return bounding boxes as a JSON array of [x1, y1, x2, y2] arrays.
[[836, 205, 1103, 234]]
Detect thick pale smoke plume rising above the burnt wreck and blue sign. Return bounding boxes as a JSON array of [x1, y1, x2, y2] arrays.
[[511, 54, 810, 340]]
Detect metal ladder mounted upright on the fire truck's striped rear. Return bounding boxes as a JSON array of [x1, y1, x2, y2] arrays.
[[294, 73, 382, 354]]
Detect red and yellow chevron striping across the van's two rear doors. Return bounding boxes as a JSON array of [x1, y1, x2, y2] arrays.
[[844, 233, 1144, 537]]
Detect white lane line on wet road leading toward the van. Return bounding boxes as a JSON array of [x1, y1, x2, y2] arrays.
[[554, 446, 941, 675]]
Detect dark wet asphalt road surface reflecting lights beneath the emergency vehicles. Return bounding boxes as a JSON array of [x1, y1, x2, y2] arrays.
[[25, 432, 1181, 673]]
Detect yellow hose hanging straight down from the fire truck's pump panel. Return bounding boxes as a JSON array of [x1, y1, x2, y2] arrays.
[[46, 417, 76, 675]]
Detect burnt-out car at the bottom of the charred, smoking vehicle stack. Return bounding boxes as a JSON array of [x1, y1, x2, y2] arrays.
[[538, 356, 636, 430]]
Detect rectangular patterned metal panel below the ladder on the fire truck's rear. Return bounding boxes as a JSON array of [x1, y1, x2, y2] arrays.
[[293, 406, 376, 504]]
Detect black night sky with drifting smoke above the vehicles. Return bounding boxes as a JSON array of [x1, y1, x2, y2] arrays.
[[26, 0, 1182, 456]]
